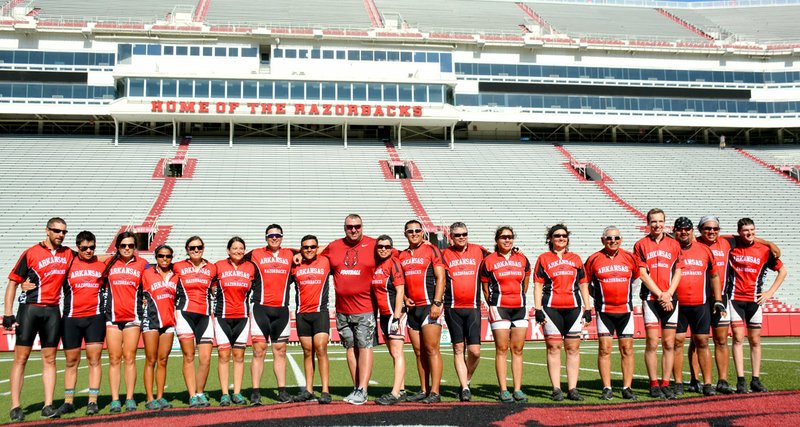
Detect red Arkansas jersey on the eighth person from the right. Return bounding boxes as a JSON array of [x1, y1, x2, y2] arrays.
[[442, 243, 489, 308]]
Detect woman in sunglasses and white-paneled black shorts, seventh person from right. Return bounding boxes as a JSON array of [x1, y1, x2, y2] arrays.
[[481, 225, 531, 403]]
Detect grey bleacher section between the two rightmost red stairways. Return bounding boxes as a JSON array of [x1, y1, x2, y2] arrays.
[[564, 143, 800, 306]]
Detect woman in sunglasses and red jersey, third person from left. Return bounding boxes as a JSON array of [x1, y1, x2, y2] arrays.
[[103, 231, 148, 413]]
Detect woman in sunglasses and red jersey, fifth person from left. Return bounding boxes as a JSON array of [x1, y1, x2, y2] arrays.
[[174, 236, 217, 408]]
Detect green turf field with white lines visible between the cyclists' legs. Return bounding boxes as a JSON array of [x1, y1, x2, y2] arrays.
[[0, 337, 800, 423]]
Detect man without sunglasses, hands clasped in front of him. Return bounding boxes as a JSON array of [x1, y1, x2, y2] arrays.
[[633, 209, 681, 399]]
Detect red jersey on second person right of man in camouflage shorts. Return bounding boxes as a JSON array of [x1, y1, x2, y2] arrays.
[[397, 244, 444, 306]]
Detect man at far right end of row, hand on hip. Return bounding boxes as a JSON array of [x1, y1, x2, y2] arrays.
[[725, 218, 787, 393]]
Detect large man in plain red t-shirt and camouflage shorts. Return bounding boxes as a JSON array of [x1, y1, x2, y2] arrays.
[[322, 214, 377, 405]]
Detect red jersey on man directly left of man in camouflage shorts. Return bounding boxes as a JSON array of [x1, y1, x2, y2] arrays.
[[292, 256, 331, 313]]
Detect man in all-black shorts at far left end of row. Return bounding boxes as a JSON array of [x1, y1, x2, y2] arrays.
[[3, 218, 73, 422]]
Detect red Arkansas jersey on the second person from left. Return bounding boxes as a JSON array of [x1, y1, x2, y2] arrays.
[[62, 256, 106, 317]]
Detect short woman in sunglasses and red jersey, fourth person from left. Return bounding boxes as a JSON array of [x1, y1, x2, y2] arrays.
[[142, 245, 179, 411]]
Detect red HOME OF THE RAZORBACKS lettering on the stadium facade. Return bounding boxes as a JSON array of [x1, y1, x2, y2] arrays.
[[150, 100, 423, 117]]
